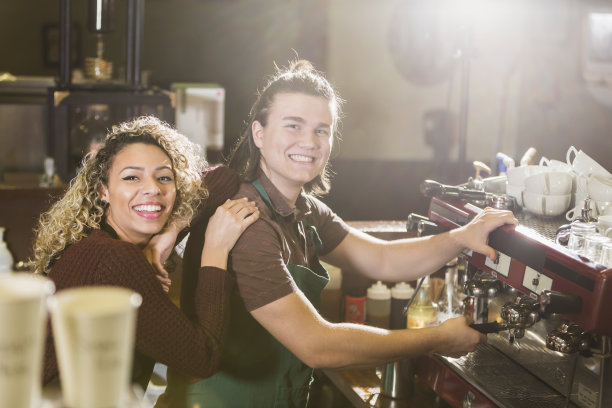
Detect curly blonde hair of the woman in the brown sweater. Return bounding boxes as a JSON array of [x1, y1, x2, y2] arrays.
[[29, 116, 208, 274]]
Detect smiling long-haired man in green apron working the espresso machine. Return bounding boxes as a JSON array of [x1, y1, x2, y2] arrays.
[[160, 61, 517, 408]]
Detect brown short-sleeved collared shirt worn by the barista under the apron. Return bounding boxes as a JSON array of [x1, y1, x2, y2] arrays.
[[231, 175, 349, 311]]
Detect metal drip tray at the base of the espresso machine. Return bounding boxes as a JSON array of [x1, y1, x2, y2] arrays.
[[441, 344, 576, 408]]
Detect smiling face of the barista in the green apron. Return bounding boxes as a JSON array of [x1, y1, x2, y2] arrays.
[[252, 93, 333, 200]]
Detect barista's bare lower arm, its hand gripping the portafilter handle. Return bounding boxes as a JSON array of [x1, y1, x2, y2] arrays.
[[251, 292, 486, 368]]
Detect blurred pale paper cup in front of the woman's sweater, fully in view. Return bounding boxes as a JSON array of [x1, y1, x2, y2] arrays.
[[48, 286, 142, 408]]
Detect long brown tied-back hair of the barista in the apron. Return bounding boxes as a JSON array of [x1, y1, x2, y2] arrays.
[[228, 60, 343, 195]]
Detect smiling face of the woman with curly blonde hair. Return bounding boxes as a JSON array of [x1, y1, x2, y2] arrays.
[[100, 143, 176, 245]]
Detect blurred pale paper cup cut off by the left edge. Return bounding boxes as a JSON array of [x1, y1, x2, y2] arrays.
[[0, 273, 55, 408]]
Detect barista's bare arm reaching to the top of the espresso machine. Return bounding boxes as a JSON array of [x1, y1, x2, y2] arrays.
[[322, 208, 518, 282]]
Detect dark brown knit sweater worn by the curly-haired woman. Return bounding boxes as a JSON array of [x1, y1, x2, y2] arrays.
[[43, 226, 234, 384]]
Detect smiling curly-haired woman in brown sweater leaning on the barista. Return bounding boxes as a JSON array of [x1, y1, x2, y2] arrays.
[[31, 117, 258, 387]]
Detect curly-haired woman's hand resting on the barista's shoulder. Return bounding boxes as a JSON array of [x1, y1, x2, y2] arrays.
[[201, 198, 259, 269]]
